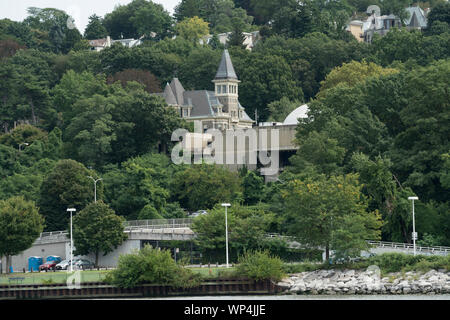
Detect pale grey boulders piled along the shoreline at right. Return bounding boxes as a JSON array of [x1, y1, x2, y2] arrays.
[[278, 266, 450, 295]]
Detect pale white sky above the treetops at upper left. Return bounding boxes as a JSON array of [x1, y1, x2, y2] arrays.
[[0, 0, 181, 33]]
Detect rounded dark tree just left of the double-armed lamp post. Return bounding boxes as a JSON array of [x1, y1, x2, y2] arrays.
[[38, 160, 103, 231]]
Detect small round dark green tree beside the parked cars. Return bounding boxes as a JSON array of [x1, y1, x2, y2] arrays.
[[73, 201, 127, 267]]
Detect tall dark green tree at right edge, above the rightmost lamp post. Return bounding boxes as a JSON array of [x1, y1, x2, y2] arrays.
[[389, 60, 450, 202]]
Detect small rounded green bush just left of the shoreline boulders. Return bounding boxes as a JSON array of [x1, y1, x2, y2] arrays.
[[232, 250, 284, 281]]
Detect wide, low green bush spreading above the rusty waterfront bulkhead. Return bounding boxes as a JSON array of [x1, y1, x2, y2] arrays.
[[110, 246, 200, 288]]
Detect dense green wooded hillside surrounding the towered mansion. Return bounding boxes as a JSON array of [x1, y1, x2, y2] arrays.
[[0, 0, 450, 258]]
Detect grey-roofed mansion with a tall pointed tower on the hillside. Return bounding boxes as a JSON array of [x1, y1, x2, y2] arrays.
[[156, 50, 254, 131]]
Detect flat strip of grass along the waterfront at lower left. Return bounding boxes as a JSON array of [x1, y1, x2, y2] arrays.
[[0, 270, 109, 285]]
